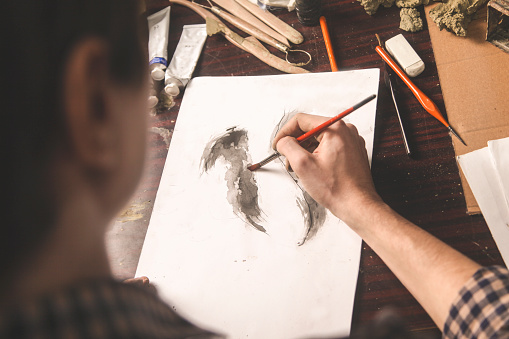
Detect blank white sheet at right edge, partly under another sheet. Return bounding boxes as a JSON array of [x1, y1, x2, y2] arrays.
[[457, 147, 509, 265]]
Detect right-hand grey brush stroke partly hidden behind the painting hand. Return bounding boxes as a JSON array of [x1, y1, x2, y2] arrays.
[[270, 112, 327, 246]]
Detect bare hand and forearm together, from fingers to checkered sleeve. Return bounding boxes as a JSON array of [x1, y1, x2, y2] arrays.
[[273, 114, 479, 328]]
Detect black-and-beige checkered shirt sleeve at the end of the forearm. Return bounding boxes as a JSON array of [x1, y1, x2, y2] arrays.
[[443, 266, 509, 338]]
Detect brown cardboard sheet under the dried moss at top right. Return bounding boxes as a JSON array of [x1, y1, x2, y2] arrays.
[[425, 4, 509, 213]]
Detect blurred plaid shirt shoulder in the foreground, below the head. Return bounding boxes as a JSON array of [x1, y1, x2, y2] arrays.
[[0, 280, 222, 339]]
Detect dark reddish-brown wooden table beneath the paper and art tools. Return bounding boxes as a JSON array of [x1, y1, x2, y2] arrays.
[[107, 0, 503, 337]]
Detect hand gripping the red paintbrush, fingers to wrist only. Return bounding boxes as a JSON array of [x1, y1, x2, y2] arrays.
[[273, 113, 380, 224]]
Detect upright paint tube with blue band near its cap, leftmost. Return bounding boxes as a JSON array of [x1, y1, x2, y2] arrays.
[[147, 6, 170, 80]]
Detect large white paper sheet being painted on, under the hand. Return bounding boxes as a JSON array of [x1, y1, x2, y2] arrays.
[[136, 69, 379, 339]]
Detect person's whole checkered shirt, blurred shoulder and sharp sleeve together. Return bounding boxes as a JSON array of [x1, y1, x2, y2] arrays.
[[0, 266, 509, 339]]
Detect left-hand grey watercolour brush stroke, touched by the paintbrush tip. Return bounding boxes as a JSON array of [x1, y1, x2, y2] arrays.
[[200, 126, 267, 233]]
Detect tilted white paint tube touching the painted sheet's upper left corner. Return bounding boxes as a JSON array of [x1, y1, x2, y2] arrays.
[[164, 24, 207, 96]]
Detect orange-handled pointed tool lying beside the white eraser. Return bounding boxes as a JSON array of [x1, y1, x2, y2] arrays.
[[375, 34, 467, 146]]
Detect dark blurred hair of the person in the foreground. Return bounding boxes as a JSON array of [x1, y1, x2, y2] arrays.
[[0, 0, 146, 278]]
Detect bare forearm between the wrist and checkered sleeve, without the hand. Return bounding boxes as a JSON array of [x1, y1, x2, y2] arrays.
[[347, 202, 480, 329]]
